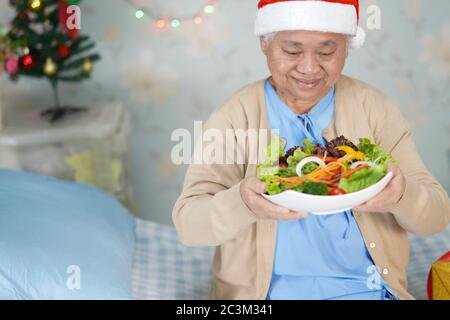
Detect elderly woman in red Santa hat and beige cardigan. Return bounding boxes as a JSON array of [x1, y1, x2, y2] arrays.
[[173, 0, 450, 300]]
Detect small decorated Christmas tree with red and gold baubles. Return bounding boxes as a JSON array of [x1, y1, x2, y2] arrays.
[[0, 0, 100, 122]]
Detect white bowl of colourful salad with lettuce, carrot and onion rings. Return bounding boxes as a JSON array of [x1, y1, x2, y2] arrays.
[[257, 136, 395, 214]]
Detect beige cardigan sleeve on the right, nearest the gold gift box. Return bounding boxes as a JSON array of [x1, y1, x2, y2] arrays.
[[375, 96, 450, 236]]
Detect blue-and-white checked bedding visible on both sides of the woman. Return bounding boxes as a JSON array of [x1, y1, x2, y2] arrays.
[[133, 219, 450, 300]]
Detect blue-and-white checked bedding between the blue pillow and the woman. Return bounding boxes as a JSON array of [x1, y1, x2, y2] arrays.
[[132, 219, 214, 300]]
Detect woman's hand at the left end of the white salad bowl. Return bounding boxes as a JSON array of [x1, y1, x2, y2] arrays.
[[240, 177, 308, 220]]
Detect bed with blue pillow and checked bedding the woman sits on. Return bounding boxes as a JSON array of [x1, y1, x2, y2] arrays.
[[0, 169, 450, 300]]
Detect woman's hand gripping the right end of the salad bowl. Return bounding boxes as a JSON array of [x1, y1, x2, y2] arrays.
[[353, 165, 406, 213]]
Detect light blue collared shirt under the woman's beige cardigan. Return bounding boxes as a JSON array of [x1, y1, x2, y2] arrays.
[[265, 81, 393, 300]]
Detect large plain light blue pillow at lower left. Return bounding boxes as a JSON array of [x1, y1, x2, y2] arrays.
[[0, 170, 135, 300]]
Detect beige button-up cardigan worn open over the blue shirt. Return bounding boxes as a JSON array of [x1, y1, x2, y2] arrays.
[[173, 76, 450, 300]]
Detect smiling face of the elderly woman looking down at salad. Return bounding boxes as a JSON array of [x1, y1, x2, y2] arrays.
[[262, 31, 348, 103]]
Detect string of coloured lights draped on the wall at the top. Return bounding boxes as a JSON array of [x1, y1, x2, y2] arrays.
[[126, 0, 217, 30]]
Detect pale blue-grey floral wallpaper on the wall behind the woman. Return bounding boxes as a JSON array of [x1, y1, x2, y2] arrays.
[[0, 0, 450, 223]]
